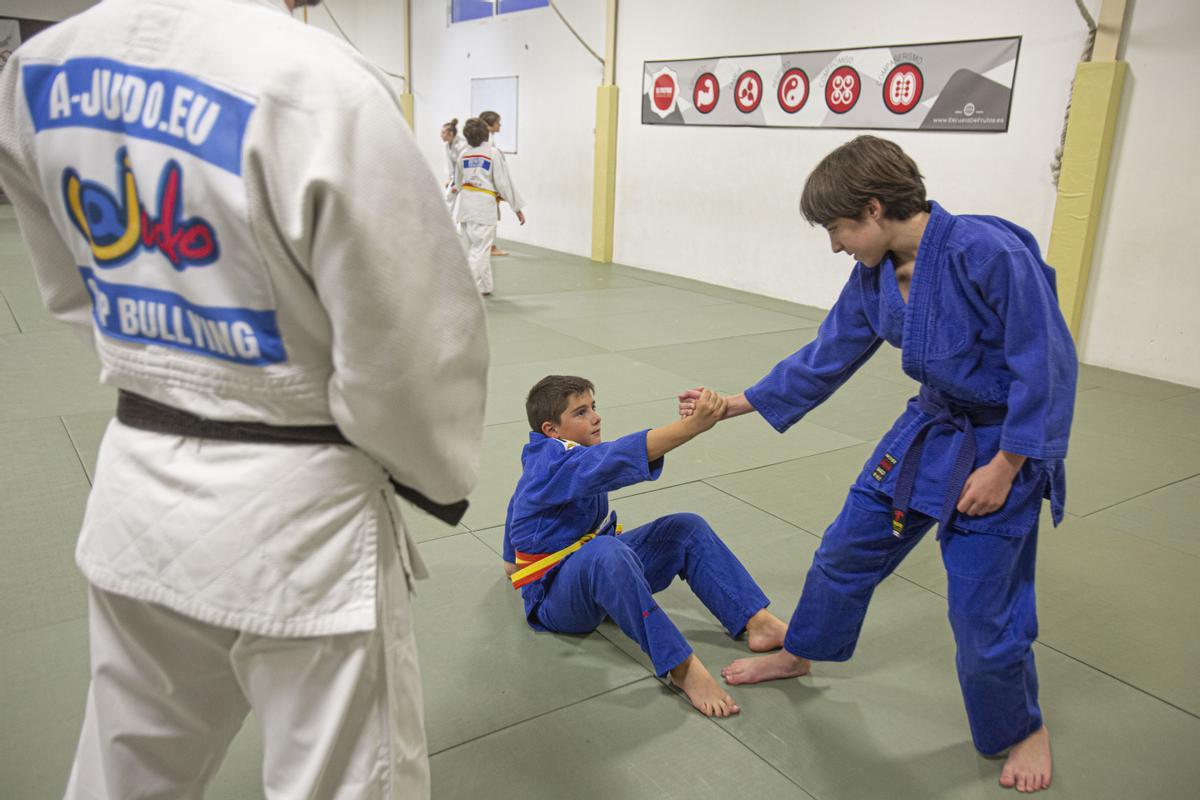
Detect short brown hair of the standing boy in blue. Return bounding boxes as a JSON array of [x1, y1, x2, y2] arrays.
[[800, 136, 929, 225]]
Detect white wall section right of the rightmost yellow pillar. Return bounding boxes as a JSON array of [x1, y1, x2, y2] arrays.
[[1080, 0, 1200, 386]]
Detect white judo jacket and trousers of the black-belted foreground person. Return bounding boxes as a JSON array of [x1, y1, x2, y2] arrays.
[[0, 0, 487, 800]]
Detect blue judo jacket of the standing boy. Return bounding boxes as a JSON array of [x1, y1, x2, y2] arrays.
[[745, 203, 1078, 536]]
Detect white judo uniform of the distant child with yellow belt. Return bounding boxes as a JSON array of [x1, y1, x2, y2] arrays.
[[455, 142, 524, 294]]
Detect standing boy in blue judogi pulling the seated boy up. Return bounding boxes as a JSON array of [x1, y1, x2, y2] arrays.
[[679, 136, 1078, 792]]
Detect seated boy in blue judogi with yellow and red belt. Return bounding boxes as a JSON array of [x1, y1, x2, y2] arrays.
[[504, 375, 786, 717]]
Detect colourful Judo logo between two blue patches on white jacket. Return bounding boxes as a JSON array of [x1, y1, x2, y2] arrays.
[[62, 148, 221, 271]]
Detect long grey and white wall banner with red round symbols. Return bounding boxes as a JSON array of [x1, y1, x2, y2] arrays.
[[642, 36, 1021, 132]]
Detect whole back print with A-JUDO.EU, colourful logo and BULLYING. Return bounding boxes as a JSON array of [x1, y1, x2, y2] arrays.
[[22, 59, 288, 366]]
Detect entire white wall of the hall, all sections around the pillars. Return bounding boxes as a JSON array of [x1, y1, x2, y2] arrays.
[[14, 0, 1200, 386]]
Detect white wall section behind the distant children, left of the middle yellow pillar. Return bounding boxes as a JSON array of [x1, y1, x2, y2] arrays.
[[413, 0, 604, 254]]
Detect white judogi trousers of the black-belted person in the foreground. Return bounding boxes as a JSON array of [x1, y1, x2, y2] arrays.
[[66, 531, 430, 800]]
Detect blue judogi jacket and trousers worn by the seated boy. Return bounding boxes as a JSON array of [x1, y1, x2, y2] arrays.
[[503, 431, 769, 676]]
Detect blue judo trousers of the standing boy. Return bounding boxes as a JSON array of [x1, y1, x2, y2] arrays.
[[784, 486, 1042, 754]]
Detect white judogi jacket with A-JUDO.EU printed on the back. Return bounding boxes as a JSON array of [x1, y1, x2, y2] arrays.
[[0, 0, 487, 636]]
